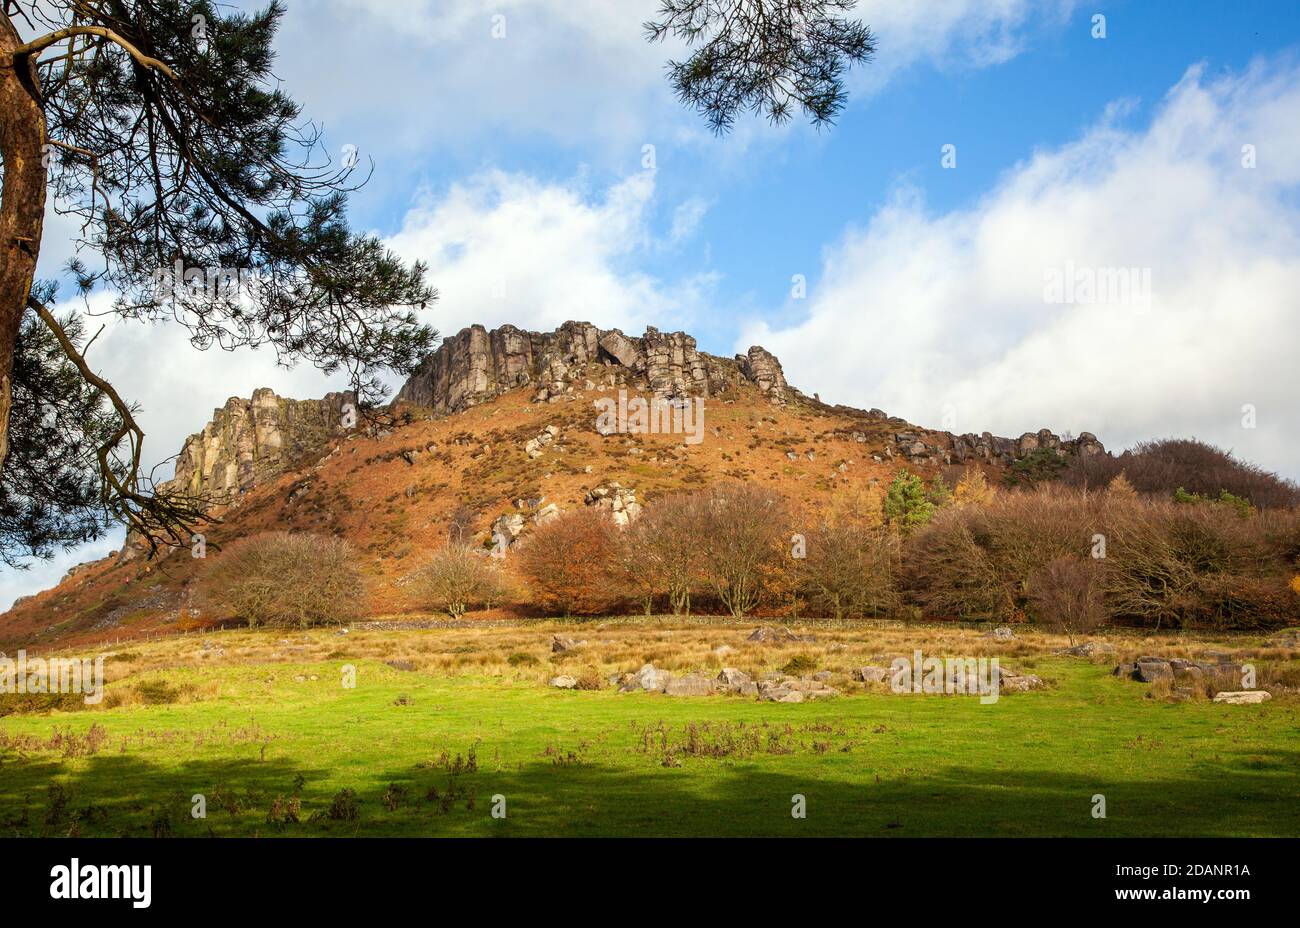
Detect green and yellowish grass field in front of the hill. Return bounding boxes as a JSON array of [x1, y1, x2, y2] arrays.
[[0, 621, 1300, 837]]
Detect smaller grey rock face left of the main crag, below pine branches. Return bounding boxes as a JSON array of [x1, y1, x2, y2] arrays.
[[160, 387, 352, 502]]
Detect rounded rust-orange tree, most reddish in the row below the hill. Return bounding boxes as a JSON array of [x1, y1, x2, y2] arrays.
[[519, 508, 621, 616]]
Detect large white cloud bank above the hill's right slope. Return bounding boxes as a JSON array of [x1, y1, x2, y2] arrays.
[[741, 58, 1300, 477]]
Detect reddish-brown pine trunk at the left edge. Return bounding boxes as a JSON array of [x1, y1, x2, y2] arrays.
[[0, 13, 46, 476]]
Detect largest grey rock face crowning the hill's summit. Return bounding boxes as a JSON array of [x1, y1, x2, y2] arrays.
[[398, 322, 774, 413]]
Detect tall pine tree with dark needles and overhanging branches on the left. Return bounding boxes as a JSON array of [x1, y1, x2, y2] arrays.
[[0, 0, 434, 556]]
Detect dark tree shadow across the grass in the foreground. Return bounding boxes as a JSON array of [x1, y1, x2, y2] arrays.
[[0, 750, 1300, 837]]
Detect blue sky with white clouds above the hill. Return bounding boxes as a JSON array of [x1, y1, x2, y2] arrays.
[[10, 0, 1300, 606]]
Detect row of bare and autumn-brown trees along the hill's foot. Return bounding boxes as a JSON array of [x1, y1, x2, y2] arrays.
[[195, 469, 1300, 633]]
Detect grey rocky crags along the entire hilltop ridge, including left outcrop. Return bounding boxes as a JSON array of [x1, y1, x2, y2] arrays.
[[163, 322, 1104, 503]]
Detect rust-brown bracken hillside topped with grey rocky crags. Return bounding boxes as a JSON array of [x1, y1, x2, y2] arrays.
[[0, 322, 1104, 649]]
